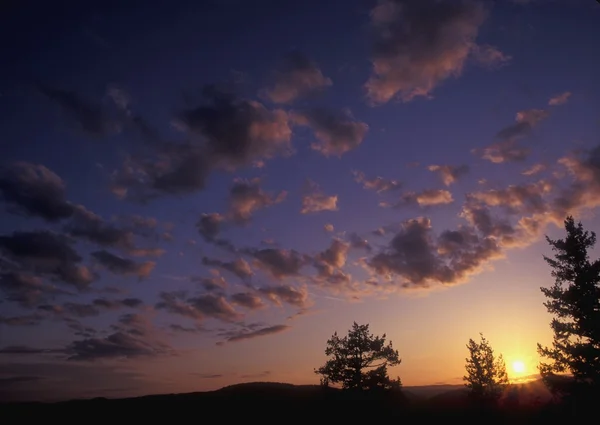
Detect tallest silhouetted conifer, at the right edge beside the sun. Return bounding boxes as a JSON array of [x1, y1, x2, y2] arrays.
[[538, 216, 600, 395]]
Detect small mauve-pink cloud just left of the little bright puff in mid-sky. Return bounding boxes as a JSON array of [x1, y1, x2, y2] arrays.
[[229, 179, 287, 224]]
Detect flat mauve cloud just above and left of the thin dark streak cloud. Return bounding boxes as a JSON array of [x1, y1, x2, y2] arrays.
[[156, 292, 241, 322]]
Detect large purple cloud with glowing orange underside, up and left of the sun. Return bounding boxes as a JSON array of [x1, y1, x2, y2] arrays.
[[367, 218, 502, 287]]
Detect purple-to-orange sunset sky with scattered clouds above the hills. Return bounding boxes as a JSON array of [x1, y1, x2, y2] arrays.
[[0, 0, 600, 400]]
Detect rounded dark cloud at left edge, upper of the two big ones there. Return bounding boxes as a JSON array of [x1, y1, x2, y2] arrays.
[[0, 162, 74, 222]]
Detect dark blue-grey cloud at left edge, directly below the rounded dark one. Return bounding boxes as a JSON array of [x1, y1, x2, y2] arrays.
[[0, 231, 94, 289]]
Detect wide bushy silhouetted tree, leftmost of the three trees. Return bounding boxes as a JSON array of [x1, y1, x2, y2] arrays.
[[315, 322, 401, 390]]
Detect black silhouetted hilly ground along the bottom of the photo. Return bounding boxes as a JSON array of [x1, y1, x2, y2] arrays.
[[0, 384, 592, 424]]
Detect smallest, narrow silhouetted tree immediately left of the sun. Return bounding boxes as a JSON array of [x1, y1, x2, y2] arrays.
[[463, 333, 508, 403]]
